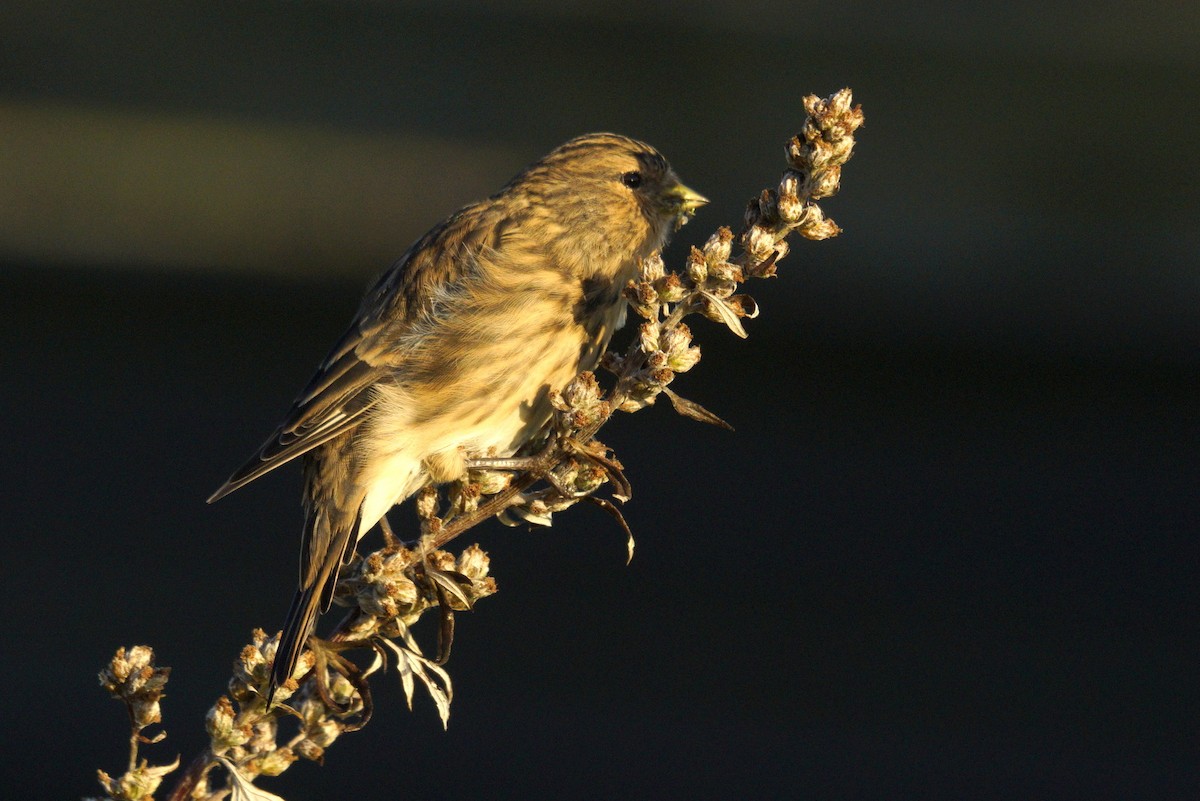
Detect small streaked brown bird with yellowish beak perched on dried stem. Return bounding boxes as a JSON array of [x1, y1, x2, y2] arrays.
[[209, 133, 707, 704]]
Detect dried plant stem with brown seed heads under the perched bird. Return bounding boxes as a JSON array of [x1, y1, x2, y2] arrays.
[[93, 89, 863, 801]]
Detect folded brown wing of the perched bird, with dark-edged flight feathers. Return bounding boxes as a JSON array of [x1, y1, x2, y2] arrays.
[[209, 199, 505, 504]]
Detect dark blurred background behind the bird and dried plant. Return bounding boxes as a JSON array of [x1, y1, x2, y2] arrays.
[[0, 0, 1200, 800]]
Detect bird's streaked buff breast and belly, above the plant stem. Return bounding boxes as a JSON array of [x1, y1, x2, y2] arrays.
[[372, 262, 624, 465]]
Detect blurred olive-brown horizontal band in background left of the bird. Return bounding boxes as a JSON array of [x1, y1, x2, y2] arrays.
[[0, 102, 520, 275]]
